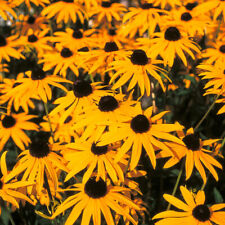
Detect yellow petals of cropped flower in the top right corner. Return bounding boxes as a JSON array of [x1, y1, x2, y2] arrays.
[[196, 0, 225, 20]]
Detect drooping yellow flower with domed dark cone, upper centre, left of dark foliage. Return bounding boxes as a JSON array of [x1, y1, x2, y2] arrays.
[[108, 49, 169, 96]]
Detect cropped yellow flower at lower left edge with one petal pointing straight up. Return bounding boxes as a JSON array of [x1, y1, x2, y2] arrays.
[[0, 151, 34, 215]]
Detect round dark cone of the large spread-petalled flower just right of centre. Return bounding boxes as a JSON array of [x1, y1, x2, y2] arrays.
[[130, 114, 150, 133]]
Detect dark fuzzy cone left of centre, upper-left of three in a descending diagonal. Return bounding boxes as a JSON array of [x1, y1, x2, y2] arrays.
[[73, 80, 93, 98]]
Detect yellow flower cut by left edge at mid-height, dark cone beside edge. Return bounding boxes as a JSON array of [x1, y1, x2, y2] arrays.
[[0, 113, 38, 150]]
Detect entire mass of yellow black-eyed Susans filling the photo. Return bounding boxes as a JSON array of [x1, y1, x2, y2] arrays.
[[0, 0, 225, 225]]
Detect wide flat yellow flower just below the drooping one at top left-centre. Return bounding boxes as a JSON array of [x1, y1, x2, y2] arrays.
[[49, 28, 97, 50]]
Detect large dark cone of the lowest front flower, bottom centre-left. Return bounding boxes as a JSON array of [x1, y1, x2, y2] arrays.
[[84, 177, 107, 199]]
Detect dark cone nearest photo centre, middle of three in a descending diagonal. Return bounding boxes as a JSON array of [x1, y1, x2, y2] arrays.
[[98, 95, 119, 112]]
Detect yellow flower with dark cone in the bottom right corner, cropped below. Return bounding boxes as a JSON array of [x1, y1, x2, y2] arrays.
[[153, 186, 225, 225]]
